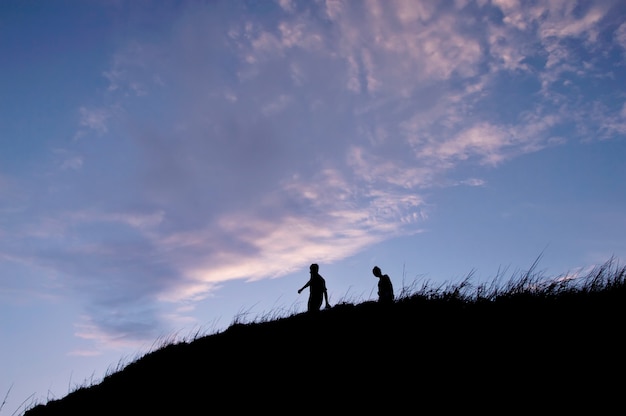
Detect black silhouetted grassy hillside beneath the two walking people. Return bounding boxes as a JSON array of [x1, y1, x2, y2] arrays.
[[25, 261, 626, 416]]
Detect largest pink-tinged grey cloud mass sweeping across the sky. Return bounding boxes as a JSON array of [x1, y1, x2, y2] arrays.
[[0, 0, 624, 345]]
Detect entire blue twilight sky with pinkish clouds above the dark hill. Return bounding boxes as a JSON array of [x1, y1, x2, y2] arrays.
[[0, 0, 626, 415]]
